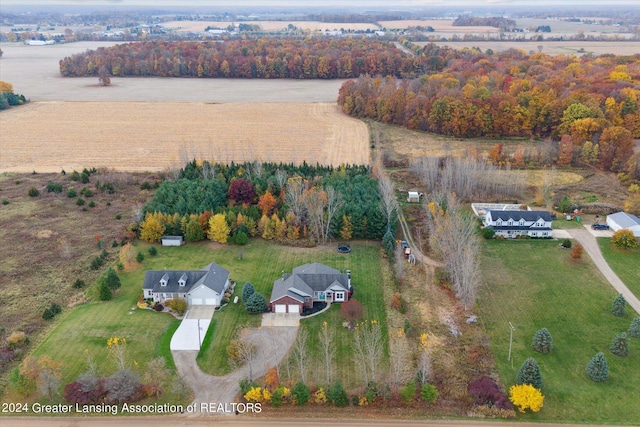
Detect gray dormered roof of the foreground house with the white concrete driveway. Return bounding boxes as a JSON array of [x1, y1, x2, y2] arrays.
[[142, 262, 229, 294]]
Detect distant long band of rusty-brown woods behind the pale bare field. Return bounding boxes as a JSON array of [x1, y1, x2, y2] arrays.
[[60, 38, 420, 79]]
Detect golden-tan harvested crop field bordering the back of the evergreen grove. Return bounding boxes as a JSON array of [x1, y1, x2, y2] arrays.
[[0, 102, 369, 172]]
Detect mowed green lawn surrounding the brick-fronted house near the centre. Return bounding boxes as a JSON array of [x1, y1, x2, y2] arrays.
[[195, 240, 386, 392]]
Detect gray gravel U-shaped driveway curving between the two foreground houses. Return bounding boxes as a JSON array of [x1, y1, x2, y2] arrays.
[[171, 326, 298, 416]]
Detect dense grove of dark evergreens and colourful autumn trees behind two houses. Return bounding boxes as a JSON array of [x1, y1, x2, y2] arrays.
[[138, 161, 388, 244]]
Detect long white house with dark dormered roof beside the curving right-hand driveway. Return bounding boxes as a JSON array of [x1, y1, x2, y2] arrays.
[[484, 210, 551, 239]]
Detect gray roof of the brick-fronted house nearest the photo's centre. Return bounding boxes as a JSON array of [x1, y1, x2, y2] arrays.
[[270, 262, 349, 302]]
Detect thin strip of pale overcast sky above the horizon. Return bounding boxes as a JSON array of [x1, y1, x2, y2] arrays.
[[0, 0, 640, 7]]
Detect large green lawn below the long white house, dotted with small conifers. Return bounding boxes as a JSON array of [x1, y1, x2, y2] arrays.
[[478, 240, 640, 425]]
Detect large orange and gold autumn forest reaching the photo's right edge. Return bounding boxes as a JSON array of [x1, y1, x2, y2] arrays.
[[338, 44, 640, 172]]
